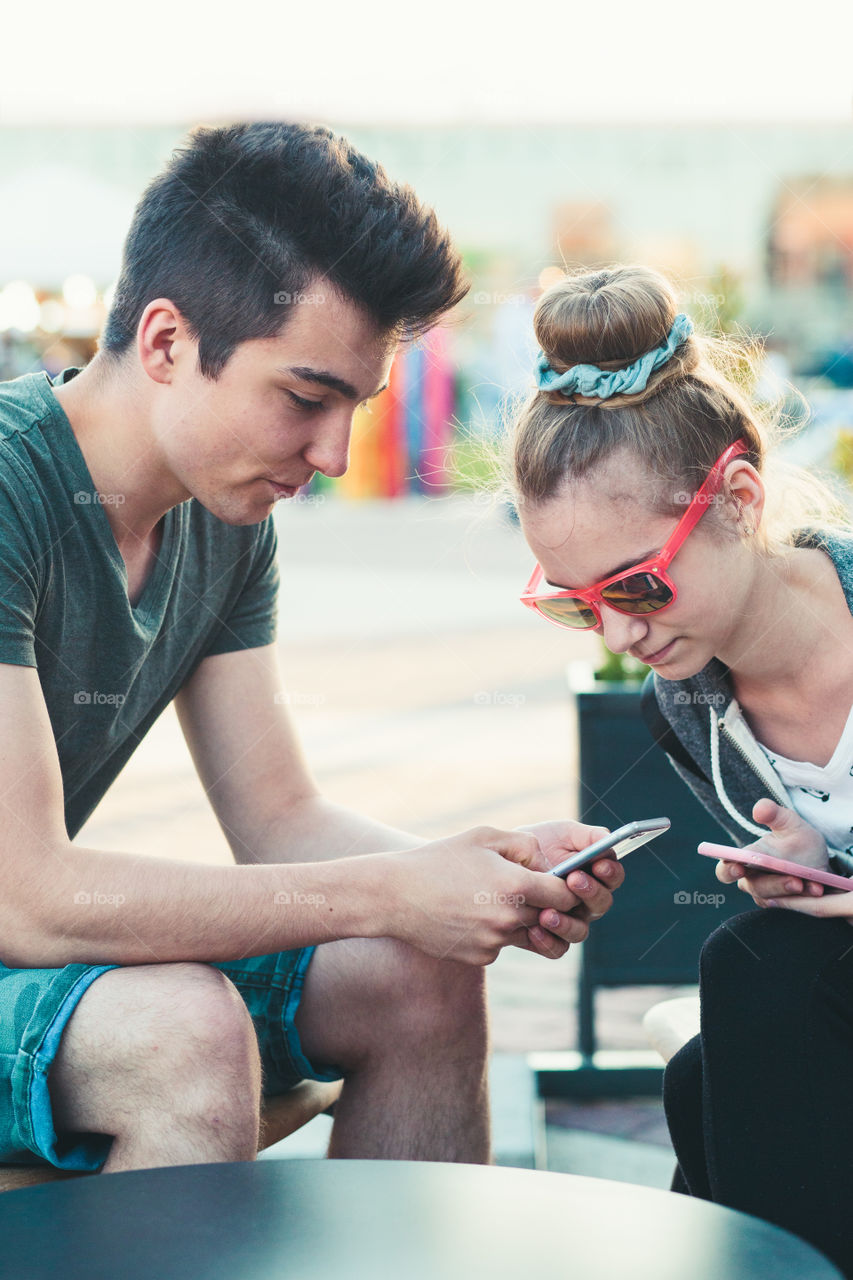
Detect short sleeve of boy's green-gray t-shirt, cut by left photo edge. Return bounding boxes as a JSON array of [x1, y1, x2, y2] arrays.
[[0, 451, 47, 667]]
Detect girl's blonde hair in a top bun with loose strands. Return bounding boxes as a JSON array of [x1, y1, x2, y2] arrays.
[[507, 265, 850, 553]]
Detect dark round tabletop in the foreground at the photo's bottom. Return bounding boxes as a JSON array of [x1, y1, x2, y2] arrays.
[[0, 1160, 840, 1280]]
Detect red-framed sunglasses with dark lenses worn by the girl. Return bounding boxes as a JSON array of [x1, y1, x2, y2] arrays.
[[521, 440, 749, 630]]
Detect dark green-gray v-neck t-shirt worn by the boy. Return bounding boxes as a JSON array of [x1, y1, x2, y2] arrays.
[[0, 369, 278, 838]]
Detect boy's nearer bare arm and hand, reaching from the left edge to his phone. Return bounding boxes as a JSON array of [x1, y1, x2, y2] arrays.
[[0, 663, 576, 968]]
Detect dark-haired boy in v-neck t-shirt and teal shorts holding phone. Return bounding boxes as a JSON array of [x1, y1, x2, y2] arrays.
[[0, 123, 622, 1170]]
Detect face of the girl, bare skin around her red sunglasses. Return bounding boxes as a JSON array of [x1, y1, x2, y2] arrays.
[[519, 451, 754, 680]]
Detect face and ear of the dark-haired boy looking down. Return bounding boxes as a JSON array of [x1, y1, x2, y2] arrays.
[[152, 283, 397, 525]]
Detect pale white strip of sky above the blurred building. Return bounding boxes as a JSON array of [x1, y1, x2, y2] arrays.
[[0, 0, 853, 125]]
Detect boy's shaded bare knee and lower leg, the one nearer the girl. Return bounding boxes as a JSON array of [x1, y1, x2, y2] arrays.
[[295, 938, 491, 1164]]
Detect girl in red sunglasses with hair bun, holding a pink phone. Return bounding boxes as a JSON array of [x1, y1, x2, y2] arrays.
[[510, 266, 853, 1276]]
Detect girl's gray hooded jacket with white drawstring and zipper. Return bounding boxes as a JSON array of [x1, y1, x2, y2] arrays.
[[645, 530, 853, 874]]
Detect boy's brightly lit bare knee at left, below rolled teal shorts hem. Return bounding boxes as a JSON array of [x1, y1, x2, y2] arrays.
[[49, 964, 260, 1171]]
